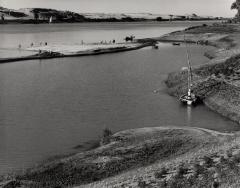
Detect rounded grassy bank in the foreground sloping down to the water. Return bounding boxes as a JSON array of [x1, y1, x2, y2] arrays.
[[7, 127, 232, 187]]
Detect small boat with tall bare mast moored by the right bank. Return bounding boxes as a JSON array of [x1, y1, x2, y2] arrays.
[[179, 34, 197, 106]]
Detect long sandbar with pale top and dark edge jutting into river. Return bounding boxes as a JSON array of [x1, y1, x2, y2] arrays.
[[0, 41, 155, 64]]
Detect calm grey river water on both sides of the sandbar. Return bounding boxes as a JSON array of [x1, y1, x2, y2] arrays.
[[0, 22, 239, 173]]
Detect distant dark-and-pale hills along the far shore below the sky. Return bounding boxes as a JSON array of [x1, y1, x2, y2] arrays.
[[0, 7, 224, 23]]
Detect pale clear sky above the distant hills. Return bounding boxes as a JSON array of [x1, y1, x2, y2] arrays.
[[0, 0, 236, 17]]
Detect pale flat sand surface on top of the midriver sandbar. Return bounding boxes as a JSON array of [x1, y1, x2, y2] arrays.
[[26, 43, 139, 55]]
